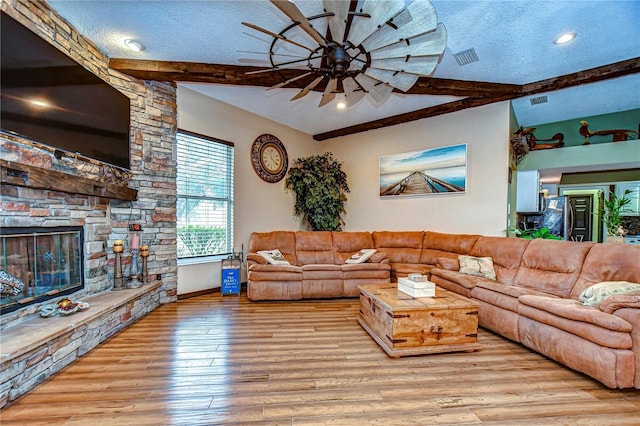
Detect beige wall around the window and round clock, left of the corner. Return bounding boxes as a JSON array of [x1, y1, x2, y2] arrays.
[[178, 85, 317, 294]]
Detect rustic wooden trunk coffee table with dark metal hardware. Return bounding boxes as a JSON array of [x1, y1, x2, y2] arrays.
[[358, 283, 481, 358]]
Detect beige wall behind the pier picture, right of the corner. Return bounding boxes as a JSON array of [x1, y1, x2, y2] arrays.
[[320, 102, 510, 235]]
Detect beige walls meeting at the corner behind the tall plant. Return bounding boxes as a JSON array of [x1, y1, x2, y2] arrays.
[[178, 86, 509, 294]]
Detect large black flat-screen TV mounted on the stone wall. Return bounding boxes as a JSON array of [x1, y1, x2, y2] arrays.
[[0, 12, 130, 169]]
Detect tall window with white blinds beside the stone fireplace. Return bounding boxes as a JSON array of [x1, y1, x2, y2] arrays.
[[177, 130, 233, 258]]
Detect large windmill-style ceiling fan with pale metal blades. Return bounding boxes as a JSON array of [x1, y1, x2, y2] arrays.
[[242, 0, 447, 107]]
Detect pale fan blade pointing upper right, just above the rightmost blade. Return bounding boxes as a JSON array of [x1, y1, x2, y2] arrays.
[[362, 0, 438, 51]]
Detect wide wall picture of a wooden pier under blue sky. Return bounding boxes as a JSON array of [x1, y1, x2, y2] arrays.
[[380, 144, 467, 197]]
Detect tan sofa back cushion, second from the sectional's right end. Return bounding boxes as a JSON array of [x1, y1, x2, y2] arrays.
[[513, 238, 593, 297]]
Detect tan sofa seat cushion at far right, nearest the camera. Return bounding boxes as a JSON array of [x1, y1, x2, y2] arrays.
[[518, 296, 632, 349]]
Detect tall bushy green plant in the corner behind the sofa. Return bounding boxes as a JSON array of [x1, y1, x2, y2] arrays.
[[284, 152, 349, 231]]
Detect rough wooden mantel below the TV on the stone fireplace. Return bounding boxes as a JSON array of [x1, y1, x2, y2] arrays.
[[0, 160, 138, 201]]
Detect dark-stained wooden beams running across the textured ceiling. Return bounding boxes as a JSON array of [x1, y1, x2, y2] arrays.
[[109, 58, 640, 141]]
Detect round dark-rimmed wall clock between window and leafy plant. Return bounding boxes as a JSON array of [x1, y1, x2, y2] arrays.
[[251, 134, 289, 183]]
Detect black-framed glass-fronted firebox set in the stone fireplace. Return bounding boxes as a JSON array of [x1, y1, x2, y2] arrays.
[[0, 226, 84, 314]]
